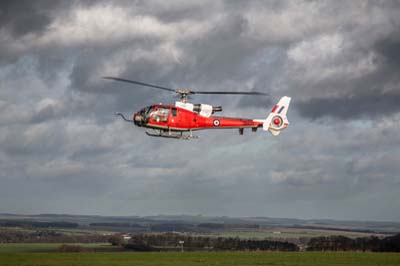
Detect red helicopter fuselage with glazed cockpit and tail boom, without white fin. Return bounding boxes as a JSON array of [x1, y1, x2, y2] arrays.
[[133, 104, 263, 132]]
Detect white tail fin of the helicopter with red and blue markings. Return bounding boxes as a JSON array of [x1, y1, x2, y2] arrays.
[[263, 96, 291, 136]]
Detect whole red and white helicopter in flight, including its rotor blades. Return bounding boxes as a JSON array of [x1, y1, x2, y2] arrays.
[[103, 76, 291, 140]]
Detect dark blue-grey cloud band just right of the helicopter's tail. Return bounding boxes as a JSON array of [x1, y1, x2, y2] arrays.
[[296, 67, 400, 120]]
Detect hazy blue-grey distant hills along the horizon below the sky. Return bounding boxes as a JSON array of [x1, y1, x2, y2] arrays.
[[0, 213, 400, 234]]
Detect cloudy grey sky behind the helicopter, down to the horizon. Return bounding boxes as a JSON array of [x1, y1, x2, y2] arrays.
[[0, 0, 400, 221]]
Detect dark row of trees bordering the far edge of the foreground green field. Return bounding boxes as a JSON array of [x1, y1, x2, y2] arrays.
[[109, 233, 400, 252]]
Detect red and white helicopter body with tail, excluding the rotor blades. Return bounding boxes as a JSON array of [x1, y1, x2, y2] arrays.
[[119, 96, 290, 139]]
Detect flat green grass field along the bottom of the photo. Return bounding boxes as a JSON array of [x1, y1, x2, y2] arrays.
[[0, 252, 400, 266]]
